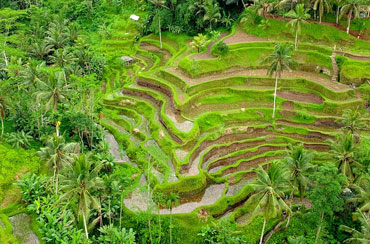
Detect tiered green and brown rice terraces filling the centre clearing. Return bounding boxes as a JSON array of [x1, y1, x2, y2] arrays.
[[102, 26, 364, 225]]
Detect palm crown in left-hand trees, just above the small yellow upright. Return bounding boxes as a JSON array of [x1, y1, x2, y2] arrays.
[[35, 72, 69, 111]]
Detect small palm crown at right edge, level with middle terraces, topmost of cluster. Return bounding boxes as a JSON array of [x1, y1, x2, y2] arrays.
[[337, 109, 367, 134]]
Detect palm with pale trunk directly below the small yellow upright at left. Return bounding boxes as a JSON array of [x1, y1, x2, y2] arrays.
[[38, 134, 80, 194]]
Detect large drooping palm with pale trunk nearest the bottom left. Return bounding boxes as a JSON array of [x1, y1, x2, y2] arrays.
[[59, 154, 104, 239]]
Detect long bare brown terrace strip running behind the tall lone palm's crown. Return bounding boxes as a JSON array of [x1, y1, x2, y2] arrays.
[[167, 67, 351, 91]]
